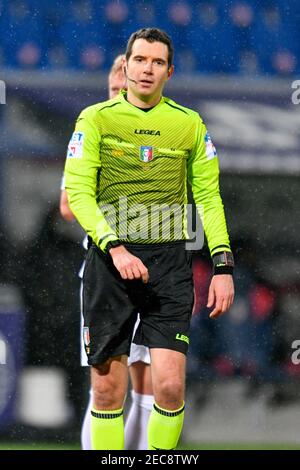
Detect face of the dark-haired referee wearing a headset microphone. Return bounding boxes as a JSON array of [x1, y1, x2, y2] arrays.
[[126, 39, 173, 101]]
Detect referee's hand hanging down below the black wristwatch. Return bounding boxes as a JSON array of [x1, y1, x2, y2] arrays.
[[207, 274, 234, 318]]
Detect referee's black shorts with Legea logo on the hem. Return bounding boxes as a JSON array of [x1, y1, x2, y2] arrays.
[[83, 242, 194, 365]]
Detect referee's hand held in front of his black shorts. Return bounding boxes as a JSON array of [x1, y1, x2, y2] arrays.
[[109, 245, 149, 283]]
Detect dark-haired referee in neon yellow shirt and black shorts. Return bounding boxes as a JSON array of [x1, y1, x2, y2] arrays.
[[65, 28, 234, 450]]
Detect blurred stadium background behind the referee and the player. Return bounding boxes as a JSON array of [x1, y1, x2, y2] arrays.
[[0, 0, 300, 449]]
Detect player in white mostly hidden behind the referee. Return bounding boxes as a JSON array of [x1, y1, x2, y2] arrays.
[[60, 56, 154, 450]]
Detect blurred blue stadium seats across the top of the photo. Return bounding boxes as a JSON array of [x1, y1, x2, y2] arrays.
[[0, 0, 300, 76]]
